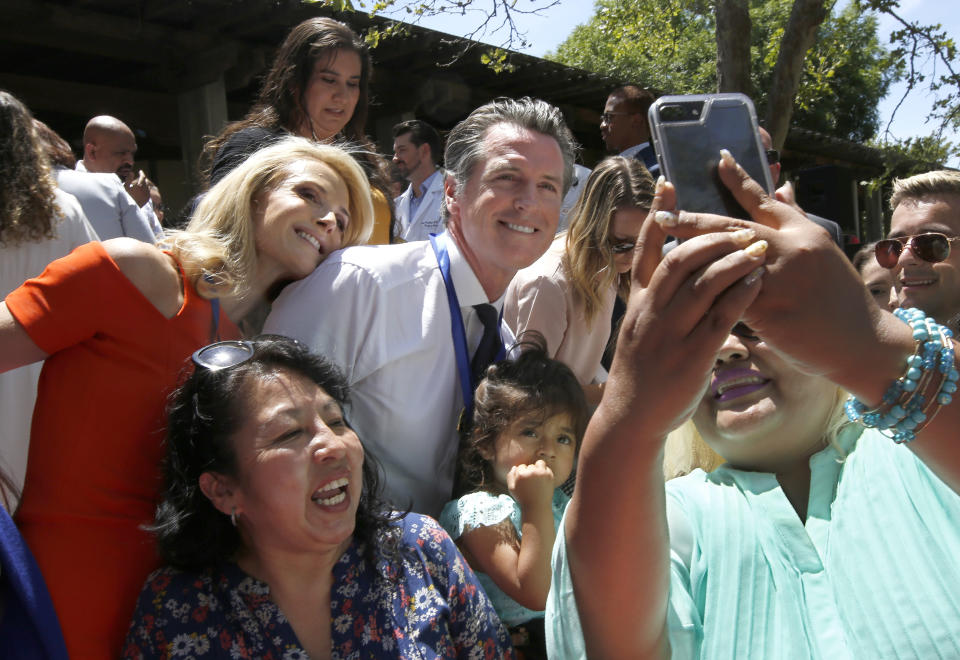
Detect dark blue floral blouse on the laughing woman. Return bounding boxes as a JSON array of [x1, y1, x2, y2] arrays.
[[124, 514, 514, 660]]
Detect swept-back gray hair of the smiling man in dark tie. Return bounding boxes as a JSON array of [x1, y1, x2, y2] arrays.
[[444, 96, 580, 195]]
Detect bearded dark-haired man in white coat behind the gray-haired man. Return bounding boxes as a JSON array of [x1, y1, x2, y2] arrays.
[[393, 119, 443, 242]]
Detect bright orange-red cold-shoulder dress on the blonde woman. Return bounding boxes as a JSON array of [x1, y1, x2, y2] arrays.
[[6, 242, 240, 659]]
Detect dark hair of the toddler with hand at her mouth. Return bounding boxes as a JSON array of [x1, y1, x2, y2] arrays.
[[454, 331, 590, 497]]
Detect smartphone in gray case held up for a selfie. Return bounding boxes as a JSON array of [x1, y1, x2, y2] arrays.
[[648, 94, 773, 218]]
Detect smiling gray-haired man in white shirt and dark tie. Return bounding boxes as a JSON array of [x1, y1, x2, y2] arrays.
[[265, 98, 576, 516]]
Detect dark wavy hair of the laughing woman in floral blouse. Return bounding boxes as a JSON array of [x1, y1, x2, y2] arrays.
[[151, 335, 397, 570]]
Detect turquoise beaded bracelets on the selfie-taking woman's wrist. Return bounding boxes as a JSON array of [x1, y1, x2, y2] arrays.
[[845, 308, 960, 443]]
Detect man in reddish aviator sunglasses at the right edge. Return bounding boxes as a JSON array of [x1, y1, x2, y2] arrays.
[[876, 170, 960, 332]]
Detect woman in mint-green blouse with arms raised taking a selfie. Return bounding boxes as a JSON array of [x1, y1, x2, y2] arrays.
[[547, 152, 960, 658]]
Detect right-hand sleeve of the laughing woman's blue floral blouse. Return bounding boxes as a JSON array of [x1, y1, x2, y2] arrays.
[[408, 516, 515, 660]]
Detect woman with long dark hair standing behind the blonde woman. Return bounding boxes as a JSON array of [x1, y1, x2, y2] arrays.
[[203, 17, 393, 244]]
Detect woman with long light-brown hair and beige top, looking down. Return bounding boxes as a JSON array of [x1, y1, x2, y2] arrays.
[[503, 156, 653, 406]]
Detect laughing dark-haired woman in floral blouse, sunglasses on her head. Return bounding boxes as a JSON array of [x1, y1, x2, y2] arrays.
[[123, 335, 513, 659]]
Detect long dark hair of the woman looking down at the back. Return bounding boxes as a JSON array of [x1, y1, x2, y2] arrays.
[[204, 17, 373, 175]]
